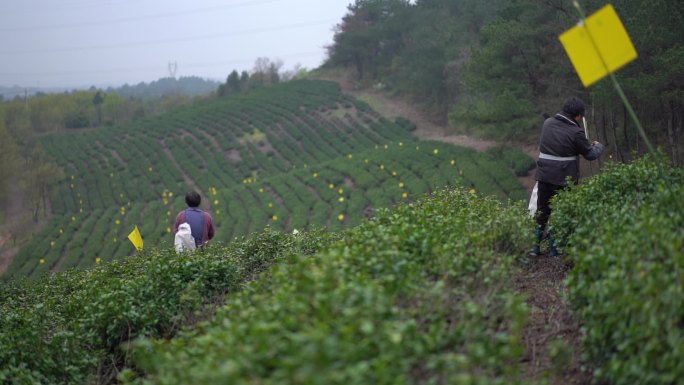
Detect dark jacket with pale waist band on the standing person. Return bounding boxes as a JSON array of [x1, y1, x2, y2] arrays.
[[535, 114, 603, 186]]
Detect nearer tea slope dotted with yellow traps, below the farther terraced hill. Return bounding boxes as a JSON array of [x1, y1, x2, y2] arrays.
[[8, 136, 525, 276]]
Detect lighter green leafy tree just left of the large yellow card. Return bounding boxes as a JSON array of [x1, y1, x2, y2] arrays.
[[449, 0, 581, 140]]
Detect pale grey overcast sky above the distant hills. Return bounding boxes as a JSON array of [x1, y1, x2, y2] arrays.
[[0, 0, 354, 87]]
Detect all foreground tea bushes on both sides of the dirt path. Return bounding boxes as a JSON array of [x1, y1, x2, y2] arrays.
[[0, 154, 684, 385]]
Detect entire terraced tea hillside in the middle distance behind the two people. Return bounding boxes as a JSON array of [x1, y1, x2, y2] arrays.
[[8, 81, 532, 276]]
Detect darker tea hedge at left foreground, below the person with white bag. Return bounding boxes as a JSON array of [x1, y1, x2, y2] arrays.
[[0, 226, 337, 384]]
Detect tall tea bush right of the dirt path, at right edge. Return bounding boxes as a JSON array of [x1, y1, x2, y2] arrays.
[[550, 158, 684, 385]]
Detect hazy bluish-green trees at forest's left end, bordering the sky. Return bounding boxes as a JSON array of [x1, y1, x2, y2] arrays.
[[326, 0, 499, 118]]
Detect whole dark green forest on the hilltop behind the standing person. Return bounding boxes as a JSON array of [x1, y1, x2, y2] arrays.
[[326, 0, 684, 160]]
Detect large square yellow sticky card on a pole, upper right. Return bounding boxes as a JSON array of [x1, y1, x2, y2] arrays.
[[559, 4, 637, 87]]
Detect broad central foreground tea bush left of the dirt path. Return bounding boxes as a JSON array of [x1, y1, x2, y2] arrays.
[[128, 190, 532, 385]]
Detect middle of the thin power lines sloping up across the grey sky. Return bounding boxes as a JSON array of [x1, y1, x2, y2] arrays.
[[0, 19, 337, 55]]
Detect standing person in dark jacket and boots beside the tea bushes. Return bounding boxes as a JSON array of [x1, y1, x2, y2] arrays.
[[529, 98, 604, 256]]
